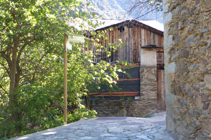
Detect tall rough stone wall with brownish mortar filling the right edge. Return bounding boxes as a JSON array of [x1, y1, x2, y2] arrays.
[[164, 0, 211, 140]]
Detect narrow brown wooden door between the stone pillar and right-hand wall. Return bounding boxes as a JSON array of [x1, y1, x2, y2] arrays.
[[157, 51, 166, 110]]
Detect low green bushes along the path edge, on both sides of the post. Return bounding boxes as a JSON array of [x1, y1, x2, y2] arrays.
[[0, 84, 97, 139]]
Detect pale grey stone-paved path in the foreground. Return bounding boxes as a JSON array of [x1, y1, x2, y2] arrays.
[[12, 112, 173, 140]]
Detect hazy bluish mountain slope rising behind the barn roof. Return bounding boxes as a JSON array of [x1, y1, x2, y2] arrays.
[[84, 0, 163, 23]]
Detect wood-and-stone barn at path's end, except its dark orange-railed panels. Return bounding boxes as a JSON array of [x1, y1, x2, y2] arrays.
[[91, 20, 165, 116]]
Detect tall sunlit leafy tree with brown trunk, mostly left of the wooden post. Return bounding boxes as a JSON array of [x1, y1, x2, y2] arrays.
[[0, 0, 79, 132]]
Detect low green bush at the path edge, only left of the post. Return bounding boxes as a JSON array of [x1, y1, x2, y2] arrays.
[[0, 85, 63, 138]]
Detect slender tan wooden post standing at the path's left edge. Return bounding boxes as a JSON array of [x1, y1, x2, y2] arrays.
[[64, 34, 67, 123]]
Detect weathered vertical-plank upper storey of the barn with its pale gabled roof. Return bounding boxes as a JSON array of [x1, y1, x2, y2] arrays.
[[93, 20, 163, 63]]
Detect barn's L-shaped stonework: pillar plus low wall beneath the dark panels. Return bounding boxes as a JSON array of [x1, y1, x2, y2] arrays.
[[90, 67, 157, 117]]
